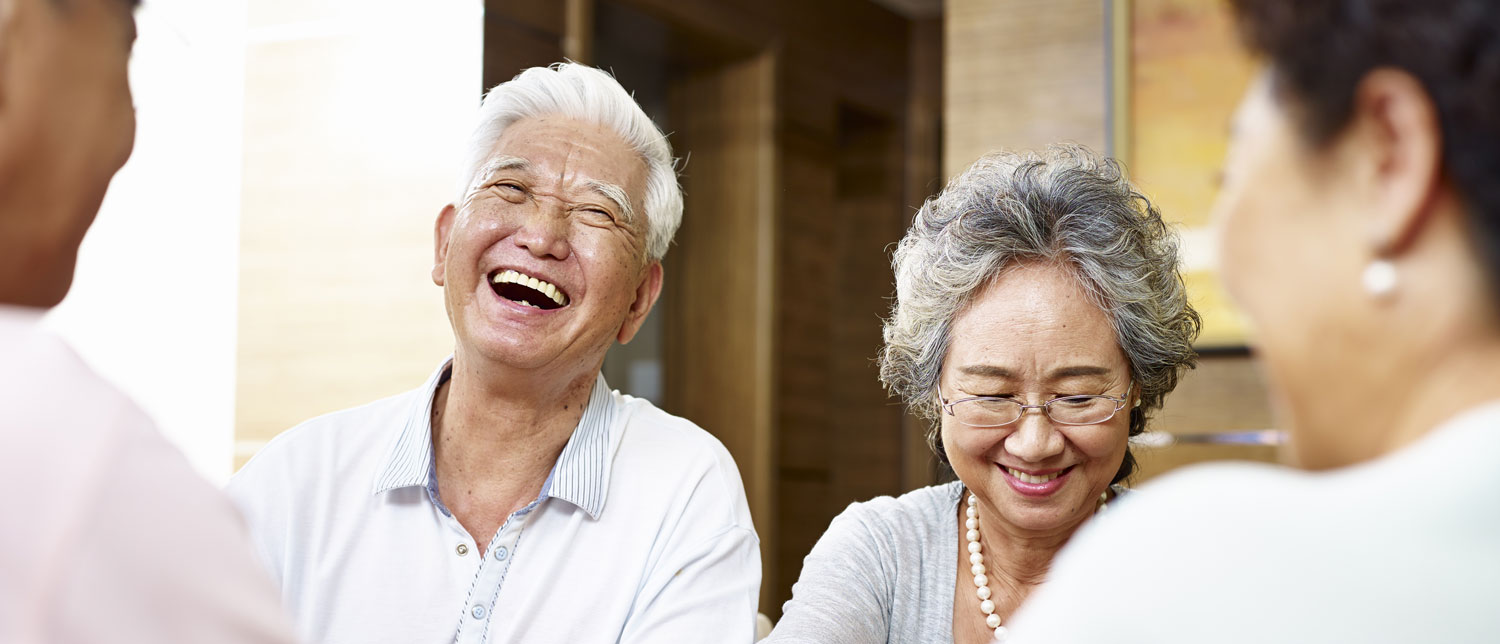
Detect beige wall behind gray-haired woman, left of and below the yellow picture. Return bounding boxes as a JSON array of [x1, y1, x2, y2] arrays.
[[944, 0, 1278, 480]]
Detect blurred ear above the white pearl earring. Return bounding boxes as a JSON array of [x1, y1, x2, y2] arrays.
[[1349, 69, 1443, 257]]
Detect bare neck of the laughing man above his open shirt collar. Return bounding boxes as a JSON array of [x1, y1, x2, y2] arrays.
[[432, 356, 597, 549]]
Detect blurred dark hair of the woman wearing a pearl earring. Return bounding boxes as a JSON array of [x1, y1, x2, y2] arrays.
[[1230, 0, 1500, 296]]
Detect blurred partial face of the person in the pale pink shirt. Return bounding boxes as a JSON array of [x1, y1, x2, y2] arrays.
[[0, 0, 135, 306]]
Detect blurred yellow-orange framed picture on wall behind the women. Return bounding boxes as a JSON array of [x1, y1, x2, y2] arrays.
[[1106, 0, 1256, 351]]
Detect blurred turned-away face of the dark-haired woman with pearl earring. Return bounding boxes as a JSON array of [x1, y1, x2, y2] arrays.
[[1214, 74, 1379, 468]]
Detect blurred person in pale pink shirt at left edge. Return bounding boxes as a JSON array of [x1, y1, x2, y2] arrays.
[[0, 0, 291, 644]]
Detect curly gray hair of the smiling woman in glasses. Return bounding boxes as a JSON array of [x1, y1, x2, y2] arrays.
[[881, 146, 1202, 482]]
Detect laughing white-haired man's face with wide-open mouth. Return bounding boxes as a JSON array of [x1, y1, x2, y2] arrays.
[[432, 117, 662, 372]]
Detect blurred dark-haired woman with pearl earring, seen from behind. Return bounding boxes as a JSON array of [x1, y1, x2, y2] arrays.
[[1016, 0, 1500, 644]]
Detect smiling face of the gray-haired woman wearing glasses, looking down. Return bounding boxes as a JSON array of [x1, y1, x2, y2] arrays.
[[939, 258, 1134, 533]]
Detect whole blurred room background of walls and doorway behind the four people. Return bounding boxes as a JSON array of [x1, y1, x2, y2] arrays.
[[48, 0, 1278, 617]]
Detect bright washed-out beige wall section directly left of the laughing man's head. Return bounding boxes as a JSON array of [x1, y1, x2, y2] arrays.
[[236, 0, 483, 465]]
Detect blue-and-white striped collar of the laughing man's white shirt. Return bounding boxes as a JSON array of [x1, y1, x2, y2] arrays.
[[372, 356, 615, 519]]
